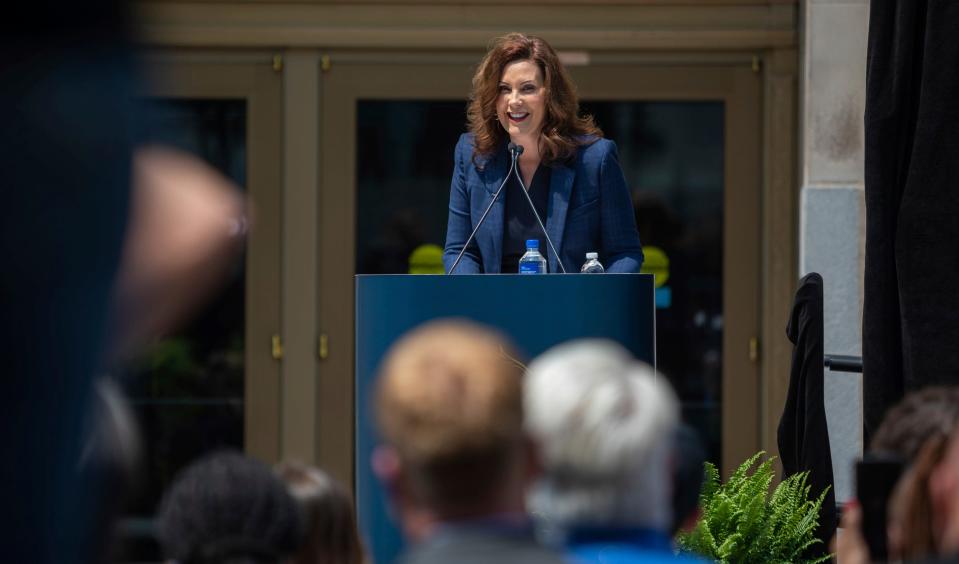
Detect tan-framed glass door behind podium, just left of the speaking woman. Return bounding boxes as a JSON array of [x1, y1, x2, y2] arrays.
[[317, 60, 472, 490]]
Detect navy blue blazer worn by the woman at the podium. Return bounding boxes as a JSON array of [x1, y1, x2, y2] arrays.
[[443, 133, 643, 274]]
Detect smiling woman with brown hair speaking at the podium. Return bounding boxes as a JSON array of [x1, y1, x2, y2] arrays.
[[443, 33, 643, 274]]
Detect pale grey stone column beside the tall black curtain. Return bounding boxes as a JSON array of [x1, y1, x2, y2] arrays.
[[799, 0, 869, 502]]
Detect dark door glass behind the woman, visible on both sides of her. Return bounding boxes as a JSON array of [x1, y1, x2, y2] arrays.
[[356, 100, 724, 464]]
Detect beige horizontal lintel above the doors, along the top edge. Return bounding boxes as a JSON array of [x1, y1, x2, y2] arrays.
[[137, 0, 796, 50]]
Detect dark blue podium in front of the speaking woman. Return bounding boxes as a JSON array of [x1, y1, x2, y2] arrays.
[[355, 274, 656, 562]]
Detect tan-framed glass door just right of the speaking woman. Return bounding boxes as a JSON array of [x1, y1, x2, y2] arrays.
[[570, 58, 762, 472]]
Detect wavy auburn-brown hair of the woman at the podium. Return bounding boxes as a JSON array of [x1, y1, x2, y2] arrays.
[[466, 33, 603, 163]]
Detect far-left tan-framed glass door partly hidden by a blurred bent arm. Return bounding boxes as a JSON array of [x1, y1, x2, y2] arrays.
[[120, 55, 281, 561]]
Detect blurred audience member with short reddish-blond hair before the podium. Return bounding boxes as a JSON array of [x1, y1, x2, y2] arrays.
[[373, 322, 562, 564]]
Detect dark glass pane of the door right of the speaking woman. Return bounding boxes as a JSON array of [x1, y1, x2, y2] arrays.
[[582, 101, 724, 464]]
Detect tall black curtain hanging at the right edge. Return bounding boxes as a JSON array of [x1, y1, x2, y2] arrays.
[[863, 0, 959, 444]]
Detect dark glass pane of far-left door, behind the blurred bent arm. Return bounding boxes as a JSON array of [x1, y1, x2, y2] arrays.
[[121, 100, 246, 560]]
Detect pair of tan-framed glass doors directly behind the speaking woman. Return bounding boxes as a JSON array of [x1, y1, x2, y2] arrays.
[[320, 54, 762, 476]]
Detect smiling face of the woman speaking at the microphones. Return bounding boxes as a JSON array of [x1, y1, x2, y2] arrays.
[[496, 60, 546, 141]]
